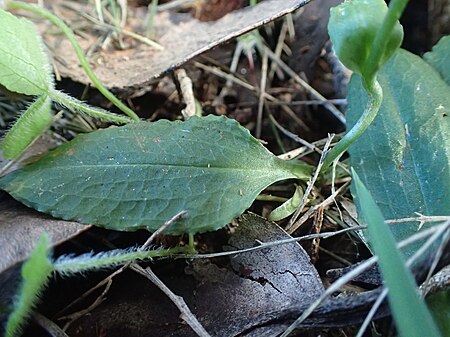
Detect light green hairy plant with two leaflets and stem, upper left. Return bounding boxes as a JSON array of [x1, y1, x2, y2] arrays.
[[0, 2, 135, 159]]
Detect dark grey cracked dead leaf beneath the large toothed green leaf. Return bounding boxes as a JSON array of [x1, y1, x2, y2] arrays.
[[60, 214, 323, 337]]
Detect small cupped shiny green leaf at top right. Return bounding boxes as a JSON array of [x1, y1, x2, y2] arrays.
[[328, 0, 403, 77]]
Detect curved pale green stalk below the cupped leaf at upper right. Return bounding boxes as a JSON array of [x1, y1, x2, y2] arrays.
[[321, 78, 383, 173]]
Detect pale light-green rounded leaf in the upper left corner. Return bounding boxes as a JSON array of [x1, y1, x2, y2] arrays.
[[0, 9, 53, 95]]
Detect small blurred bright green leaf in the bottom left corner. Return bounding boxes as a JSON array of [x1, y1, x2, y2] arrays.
[[5, 234, 53, 337]]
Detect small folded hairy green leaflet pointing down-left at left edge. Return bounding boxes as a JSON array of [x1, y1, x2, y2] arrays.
[[0, 94, 53, 159]]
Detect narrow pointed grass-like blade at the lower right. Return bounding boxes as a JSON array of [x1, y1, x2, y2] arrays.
[[352, 169, 440, 337]]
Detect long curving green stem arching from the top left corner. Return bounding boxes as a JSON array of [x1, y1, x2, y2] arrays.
[[7, 1, 139, 121]]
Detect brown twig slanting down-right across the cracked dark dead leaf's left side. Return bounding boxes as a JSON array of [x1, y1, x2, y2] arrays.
[[130, 263, 210, 337]]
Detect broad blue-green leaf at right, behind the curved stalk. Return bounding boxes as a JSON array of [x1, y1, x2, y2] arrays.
[[347, 50, 450, 255]]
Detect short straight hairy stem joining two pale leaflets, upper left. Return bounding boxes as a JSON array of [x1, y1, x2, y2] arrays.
[[48, 89, 132, 124]]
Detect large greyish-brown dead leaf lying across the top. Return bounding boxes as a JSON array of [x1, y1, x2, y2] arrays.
[[33, 0, 308, 91]]
